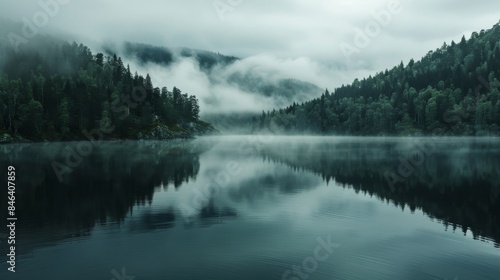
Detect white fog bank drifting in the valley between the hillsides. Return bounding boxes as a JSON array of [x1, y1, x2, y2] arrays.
[[119, 49, 329, 115]]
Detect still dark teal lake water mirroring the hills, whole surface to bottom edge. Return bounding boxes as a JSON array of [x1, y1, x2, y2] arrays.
[[0, 136, 500, 280]]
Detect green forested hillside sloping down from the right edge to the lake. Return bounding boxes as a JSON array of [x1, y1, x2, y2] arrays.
[[253, 21, 500, 135]]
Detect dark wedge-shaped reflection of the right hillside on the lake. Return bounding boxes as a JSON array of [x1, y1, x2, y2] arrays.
[[262, 138, 500, 247]]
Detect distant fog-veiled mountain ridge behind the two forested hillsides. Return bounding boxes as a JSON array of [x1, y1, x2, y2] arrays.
[[109, 42, 321, 109]]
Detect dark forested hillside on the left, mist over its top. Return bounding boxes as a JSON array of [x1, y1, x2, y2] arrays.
[[0, 37, 214, 141]]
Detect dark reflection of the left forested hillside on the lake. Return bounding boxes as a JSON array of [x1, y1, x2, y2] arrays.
[[0, 141, 213, 254]]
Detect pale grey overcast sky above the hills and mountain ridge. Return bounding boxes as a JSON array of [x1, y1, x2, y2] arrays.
[[0, 0, 500, 92]]
